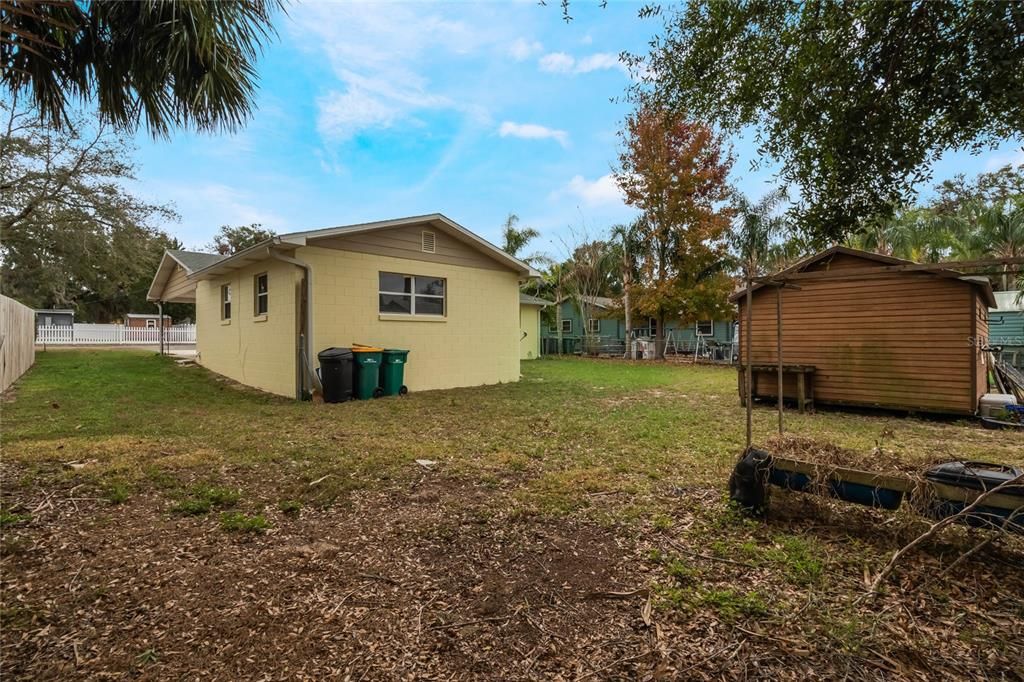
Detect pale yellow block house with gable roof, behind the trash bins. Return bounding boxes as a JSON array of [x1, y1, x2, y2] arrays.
[[147, 214, 538, 397]]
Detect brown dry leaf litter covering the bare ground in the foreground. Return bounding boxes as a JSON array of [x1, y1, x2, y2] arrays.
[[0, 471, 1024, 680]]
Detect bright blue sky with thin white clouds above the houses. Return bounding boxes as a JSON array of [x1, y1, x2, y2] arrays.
[[128, 0, 1024, 254]]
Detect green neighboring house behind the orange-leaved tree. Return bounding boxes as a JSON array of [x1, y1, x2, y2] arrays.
[[541, 296, 736, 360]]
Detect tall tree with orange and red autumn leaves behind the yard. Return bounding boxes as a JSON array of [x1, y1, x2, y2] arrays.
[[615, 108, 732, 359]]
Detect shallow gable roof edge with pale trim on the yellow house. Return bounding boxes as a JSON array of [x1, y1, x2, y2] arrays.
[[189, 213, 541, 279]]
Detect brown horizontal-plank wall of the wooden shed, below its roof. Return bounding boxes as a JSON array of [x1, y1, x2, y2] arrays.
[[737, 272, 980, 413]]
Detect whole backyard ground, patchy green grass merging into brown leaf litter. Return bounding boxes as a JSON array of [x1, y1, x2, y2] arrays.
[[0, 350, 1024, 679]]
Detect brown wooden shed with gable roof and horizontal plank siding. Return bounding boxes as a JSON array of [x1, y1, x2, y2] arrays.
[[731, 247, 994, 415]]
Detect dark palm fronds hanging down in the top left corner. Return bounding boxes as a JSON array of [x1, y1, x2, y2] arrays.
[[0, 0, 284, 136]]
